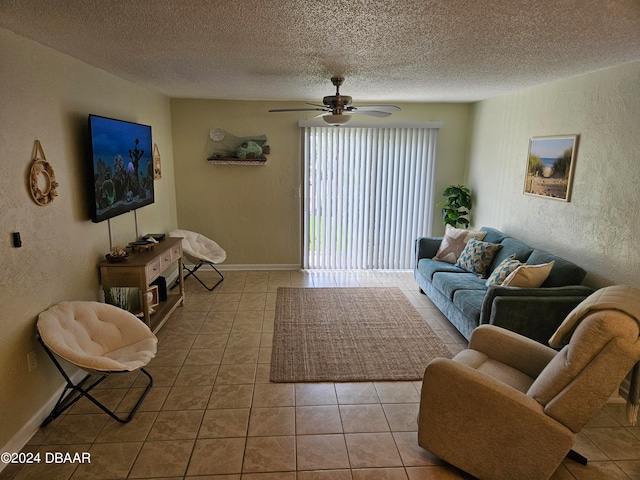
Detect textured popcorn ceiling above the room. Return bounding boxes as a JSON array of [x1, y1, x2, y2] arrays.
[[0, 0, 640, 103]]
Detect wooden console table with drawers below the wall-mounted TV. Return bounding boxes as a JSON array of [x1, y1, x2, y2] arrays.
[[98, 237, 184, 333]]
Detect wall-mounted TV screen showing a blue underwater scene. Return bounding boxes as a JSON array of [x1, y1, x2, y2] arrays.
[[89, 115, 154, 223]]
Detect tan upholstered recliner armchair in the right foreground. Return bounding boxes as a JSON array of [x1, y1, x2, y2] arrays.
[[418, 286, 640, 480]]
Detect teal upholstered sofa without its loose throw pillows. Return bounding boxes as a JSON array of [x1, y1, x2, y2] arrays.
[[414, 227, 593, 345]]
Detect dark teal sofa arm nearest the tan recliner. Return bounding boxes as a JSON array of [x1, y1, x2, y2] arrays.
[[480, 285, 593, 345]]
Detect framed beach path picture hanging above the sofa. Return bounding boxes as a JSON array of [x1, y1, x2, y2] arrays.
[[524, 135, 578, 202]]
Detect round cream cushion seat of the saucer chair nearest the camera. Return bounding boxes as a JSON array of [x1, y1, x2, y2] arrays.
[[37, 301, 158, 372]]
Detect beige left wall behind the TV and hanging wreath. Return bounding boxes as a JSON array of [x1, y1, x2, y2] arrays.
[[0, 29, 177, 446]]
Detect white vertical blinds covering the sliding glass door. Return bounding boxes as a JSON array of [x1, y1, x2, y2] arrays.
[[301, 124, 439, 269]]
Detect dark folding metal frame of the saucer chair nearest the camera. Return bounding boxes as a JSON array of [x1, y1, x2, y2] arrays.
[[36, 302, 157, 427]]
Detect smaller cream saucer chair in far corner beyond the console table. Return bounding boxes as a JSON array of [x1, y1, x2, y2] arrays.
[[169, 230, 227, 292]]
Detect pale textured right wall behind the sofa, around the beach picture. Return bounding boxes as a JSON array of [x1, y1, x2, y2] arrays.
[[467, 62, 640, 286]]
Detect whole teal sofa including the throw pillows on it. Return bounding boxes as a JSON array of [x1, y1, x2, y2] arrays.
[[414, 227, 593, 345]]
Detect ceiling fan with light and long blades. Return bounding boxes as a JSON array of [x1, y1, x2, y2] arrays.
[[269, 77, 400, 126]]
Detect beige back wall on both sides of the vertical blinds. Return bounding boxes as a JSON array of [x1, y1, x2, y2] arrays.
[[171, 99, 470, 266]]
